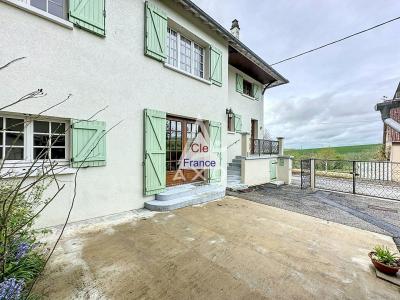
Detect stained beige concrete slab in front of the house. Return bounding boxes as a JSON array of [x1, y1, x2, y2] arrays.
[[35, 197, 400, 299]]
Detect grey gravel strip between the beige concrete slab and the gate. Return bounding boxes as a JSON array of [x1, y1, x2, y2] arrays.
[[229, 185, 400, 250]]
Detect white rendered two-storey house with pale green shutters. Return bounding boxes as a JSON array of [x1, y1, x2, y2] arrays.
[[0, 0, 289, 226]]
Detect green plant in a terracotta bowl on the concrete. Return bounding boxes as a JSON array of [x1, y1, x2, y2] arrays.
[[368, 246, 400, 276]]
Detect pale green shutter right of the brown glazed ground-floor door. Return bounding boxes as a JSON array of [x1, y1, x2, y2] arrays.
[[209, 121, 222, 182]]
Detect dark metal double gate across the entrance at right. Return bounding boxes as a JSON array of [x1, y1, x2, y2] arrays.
[[311, 159, 400, 200]]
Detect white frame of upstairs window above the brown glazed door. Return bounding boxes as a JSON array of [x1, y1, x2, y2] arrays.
[[165, 27, 206, 80]]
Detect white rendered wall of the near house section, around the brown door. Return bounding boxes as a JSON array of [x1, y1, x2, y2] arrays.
[[0, 0, 233, 226]]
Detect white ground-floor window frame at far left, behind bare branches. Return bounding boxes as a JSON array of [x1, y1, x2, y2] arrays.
[[0, 113, 71, 167]]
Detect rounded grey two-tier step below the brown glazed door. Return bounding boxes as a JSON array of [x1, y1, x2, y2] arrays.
[[144, 184, 225, 211]]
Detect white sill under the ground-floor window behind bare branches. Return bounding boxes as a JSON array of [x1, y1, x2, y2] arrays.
[[0, 160, 77, 179]]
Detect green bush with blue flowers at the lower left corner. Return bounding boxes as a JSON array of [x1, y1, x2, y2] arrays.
[[0, 179, 50, 299]]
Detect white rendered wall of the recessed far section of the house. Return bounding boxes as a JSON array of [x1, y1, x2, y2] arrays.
[[227, 66, 264, 162]]
